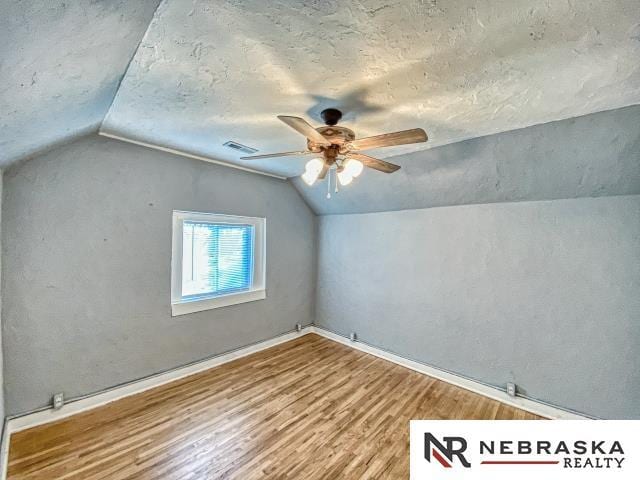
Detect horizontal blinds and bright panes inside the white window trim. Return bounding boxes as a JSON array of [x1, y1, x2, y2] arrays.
[[182, 221, 255, 299]]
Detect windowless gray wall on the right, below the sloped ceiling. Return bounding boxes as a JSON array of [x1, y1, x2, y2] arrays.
[[316, 196, 640, 418]]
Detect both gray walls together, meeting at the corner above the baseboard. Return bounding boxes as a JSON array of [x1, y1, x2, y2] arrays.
[[1, 136, 640, 418]]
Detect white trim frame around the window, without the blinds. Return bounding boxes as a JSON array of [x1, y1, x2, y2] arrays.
[[171, 210, 267, 317]]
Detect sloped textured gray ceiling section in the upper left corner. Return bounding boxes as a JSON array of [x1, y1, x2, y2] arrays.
[[0, 0, 159, 168]]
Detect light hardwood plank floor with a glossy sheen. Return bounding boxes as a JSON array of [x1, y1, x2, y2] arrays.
[[9, 334, 537, 480]]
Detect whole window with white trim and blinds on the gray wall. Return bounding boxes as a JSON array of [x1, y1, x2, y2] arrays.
[[171, 212, 266, 316]]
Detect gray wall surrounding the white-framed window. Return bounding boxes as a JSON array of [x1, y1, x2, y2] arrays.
[[2, 136, 316, 414]]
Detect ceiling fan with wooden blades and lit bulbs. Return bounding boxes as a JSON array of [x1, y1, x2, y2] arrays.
[[240, 108, 427, 191]]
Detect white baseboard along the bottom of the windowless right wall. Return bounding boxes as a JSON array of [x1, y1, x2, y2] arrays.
[[312, 326, 591, 420]]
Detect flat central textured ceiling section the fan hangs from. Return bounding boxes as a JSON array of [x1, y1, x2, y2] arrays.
[[102, 0, 640, 176]]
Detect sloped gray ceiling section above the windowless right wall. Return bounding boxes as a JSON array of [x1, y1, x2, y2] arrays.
[[293, 106, 640, 214]]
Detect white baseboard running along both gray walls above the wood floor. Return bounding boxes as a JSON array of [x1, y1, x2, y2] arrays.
[[0, 326, 589, 480]]
